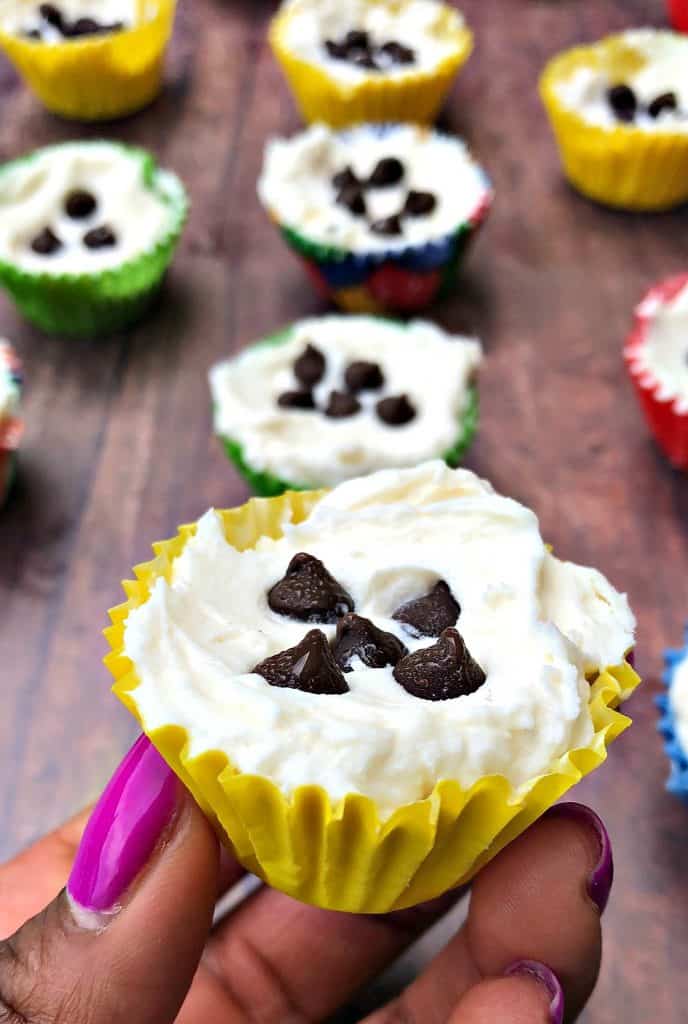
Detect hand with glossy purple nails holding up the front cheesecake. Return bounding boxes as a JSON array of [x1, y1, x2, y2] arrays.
[[0, 737, 612, 1024]]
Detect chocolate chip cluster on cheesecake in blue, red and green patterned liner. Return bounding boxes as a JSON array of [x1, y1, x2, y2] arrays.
[[332, 157, 437, 236]]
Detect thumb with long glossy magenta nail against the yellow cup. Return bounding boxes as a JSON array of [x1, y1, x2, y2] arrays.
[[0, 736, 219, 1024]]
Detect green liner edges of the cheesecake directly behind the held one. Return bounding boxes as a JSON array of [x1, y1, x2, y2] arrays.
[[213, 317, 480, 498]]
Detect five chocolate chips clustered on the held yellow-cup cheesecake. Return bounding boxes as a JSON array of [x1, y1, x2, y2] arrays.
[[253, 552, 486, 700]]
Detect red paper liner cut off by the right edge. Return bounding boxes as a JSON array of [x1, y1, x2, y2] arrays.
[[624, 273, 688, 470]]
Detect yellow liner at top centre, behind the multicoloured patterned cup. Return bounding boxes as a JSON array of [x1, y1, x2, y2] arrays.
[[269, 0, 473, 128]]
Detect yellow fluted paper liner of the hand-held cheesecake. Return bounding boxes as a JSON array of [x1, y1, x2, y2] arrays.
[[105, 492, 640, 913]]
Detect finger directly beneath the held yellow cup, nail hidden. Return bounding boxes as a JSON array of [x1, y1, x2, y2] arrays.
[[180, 889, 462, 1024]]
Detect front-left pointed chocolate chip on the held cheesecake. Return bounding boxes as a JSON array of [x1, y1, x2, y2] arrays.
[[253, 630, 349, 694]]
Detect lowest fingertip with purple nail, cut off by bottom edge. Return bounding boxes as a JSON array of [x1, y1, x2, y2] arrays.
[[448, 961, 564, 1024]]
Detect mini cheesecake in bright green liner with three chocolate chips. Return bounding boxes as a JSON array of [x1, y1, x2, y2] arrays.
[[0, 141, 186, 334]]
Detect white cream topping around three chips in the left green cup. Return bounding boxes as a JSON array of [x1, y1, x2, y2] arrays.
[[0, 142, 173, 274]]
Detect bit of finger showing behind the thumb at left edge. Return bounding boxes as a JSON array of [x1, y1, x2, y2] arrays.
[[0, 810, 89, 935]]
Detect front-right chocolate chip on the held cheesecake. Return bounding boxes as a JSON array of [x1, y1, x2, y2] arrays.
[[394, 630, 486, 700]]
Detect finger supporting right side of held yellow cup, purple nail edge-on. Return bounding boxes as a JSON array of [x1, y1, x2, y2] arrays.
[[371, 804, 613, 1024]]
